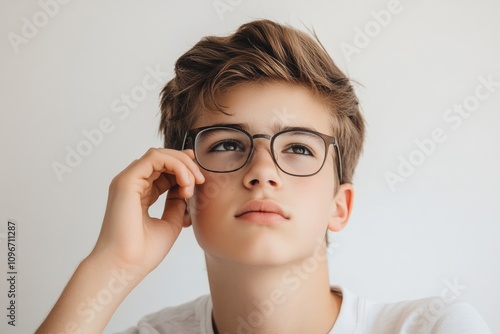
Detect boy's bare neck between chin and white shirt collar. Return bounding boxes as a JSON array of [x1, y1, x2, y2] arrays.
[[207, 255, 342, 333]]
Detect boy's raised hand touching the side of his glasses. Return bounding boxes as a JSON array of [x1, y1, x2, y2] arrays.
[[90, 149, 205, 276]]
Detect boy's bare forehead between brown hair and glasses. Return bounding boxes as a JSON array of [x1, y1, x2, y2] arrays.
[[193, 82, 332, 134]]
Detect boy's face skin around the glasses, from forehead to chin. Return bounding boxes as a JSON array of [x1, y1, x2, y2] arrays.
[[185, 83, 352, 265]]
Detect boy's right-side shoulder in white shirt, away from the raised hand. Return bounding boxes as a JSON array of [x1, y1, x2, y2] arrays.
[[332, 287, 490, 334]]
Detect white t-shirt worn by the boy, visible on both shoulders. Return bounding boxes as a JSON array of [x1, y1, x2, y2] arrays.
[[116, 286, 491, 334]]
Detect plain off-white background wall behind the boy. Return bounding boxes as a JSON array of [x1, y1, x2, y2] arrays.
[[0, 0, 500, 333]]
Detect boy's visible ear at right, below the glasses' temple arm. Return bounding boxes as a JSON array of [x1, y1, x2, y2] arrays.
[[328, 183, 354, 232]]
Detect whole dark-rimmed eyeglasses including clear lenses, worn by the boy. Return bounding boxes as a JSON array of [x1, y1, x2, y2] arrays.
[[182, 126, 342, 183]]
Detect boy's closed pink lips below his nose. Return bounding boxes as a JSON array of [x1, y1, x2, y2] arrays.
[[234, 200, 289, 224]]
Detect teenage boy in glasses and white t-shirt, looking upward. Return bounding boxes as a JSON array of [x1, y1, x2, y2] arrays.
[[38, 20, 489, 334]]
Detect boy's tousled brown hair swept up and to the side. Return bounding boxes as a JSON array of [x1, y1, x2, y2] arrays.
[[160, 20, 365, 183]]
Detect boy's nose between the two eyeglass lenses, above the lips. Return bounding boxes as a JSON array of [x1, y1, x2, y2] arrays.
[[243, 135, 282, 189]]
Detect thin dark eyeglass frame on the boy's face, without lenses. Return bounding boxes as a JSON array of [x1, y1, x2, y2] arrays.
[[182, 125, 342, 184]]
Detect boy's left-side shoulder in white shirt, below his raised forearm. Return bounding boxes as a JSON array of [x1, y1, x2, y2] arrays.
[[115, 295, 212, 334]]
